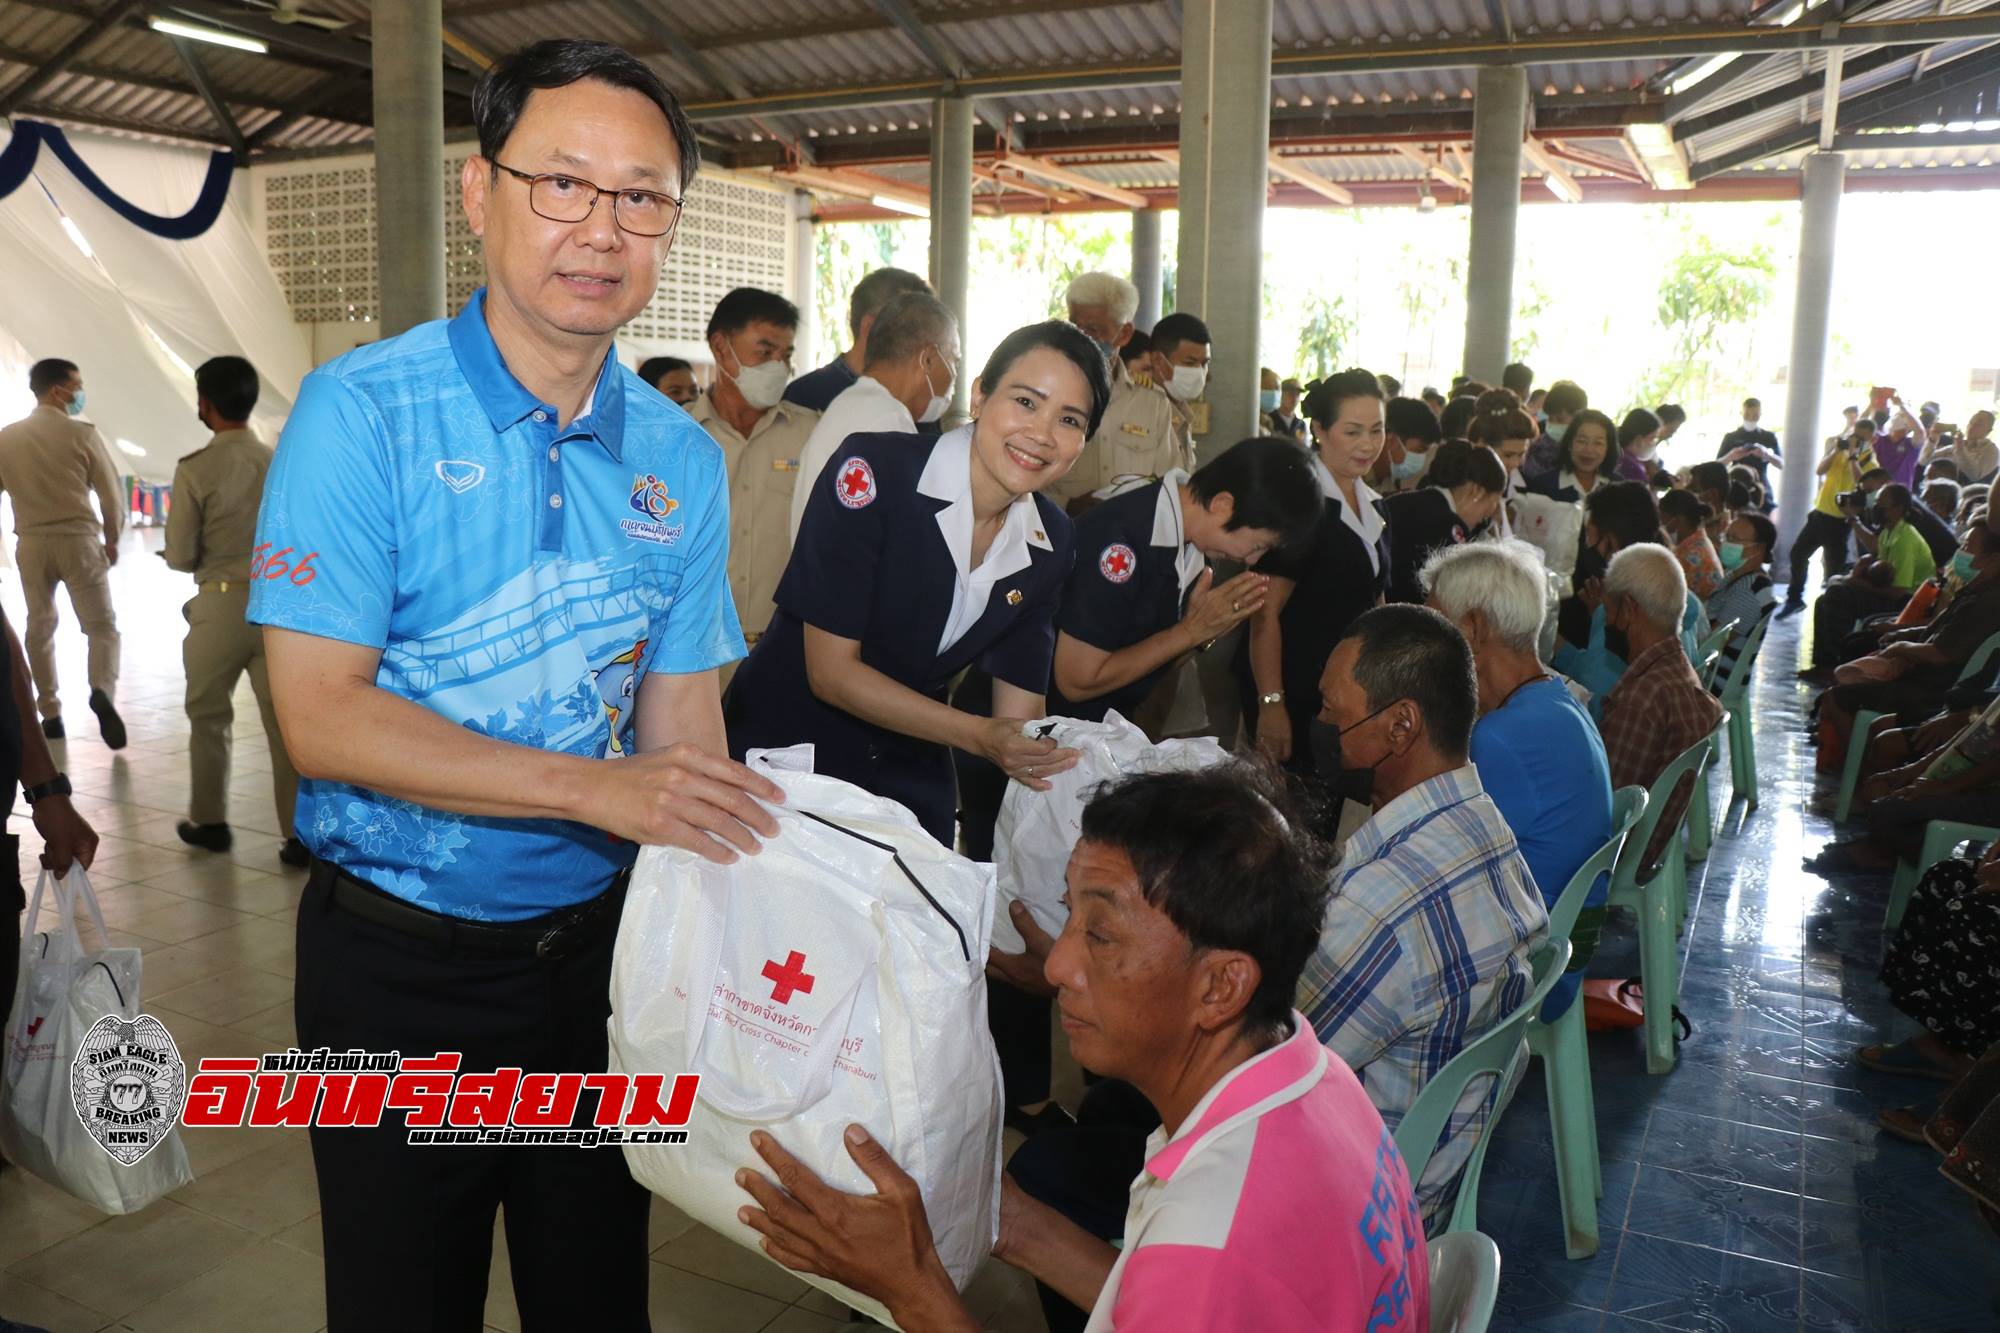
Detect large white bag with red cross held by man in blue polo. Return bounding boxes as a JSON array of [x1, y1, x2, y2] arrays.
[[610, 747, 1000, 1323]]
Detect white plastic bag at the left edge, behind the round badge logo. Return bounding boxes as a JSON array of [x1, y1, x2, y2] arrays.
[[0, 867, 194, 1213]]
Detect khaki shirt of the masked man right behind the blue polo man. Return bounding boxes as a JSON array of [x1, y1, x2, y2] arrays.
[[688, 392, 820, 642]]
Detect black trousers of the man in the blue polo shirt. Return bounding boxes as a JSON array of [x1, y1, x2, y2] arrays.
[[294, 875, 650, 1333]]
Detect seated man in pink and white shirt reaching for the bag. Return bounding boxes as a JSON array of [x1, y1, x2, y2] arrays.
[[738, 769, 1430, 1333]]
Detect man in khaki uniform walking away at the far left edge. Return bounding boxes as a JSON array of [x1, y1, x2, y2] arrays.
[[0, 358, 126, 751]]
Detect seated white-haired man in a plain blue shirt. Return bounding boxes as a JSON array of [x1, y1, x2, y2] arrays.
[[1422, 540, 1612, 1000]]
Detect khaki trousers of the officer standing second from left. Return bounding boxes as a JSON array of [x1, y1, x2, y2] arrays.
[[180, 582, 298, 837]]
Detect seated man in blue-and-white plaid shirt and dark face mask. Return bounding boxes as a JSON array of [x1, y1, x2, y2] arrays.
[[1298, 606, 1548, 1223]]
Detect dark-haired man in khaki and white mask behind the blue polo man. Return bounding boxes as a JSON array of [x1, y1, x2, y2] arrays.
[[688, 286, 820, 644]]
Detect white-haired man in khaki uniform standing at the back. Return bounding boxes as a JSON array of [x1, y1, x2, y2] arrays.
[[1046, 272, 1192, 514]]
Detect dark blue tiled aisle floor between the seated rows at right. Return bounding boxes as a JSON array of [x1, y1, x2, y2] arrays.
[[1480, 616, 2000, 1333]]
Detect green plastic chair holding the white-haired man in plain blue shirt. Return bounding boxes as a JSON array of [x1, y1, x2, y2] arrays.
[[1528, 787, 1646, 1259]]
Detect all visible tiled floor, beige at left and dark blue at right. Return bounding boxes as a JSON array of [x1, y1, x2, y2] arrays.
[[0, 532, 2000, 1333]]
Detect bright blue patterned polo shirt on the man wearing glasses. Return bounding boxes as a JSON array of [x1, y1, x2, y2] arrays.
[[250, 290, 744, 921]]
